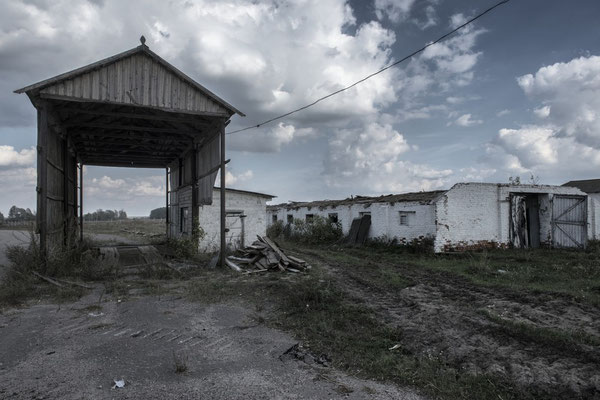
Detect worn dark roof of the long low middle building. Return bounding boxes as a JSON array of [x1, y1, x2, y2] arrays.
[[267, 190, 446, 210]]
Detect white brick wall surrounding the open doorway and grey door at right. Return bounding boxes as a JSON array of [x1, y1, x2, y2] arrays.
[[434, 183, 590, 252]]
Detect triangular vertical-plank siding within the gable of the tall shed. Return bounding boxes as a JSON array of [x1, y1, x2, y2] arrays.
[[40, 53, 231, 116]]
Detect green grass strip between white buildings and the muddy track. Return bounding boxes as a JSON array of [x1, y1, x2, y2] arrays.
[[286, 243, 600, 305]]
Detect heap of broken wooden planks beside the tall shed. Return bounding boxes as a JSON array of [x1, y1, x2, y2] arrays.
[[225, 236, 311, 274]]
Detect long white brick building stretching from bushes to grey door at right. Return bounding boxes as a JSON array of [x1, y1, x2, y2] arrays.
[[268, 183, 598, 252]]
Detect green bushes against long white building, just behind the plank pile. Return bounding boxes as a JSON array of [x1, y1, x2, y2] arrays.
[[267, 215, 344, 244]]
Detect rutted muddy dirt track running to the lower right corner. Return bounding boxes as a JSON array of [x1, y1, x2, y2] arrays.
[[302, 251, 600, 398]]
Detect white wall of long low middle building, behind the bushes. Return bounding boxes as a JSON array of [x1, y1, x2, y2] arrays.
[[268, 202, 436, 241]]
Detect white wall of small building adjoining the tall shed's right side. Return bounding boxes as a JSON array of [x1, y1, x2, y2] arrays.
[[198, 189, 270, 252]]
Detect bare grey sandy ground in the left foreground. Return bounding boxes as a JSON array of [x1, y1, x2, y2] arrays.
[[0, 285, 423, 399]]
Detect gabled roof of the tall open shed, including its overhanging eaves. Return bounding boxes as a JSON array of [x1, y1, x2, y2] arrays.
[[15, 44, 245, 116]]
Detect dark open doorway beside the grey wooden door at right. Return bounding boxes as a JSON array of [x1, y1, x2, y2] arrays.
[[510, 193, 541, 249]]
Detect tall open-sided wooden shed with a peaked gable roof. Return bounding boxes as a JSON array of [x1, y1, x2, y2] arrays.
[[15, 36, 244, 264]]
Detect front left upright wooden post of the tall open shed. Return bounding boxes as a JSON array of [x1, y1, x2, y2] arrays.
[[37, 102, 48, 259]]
